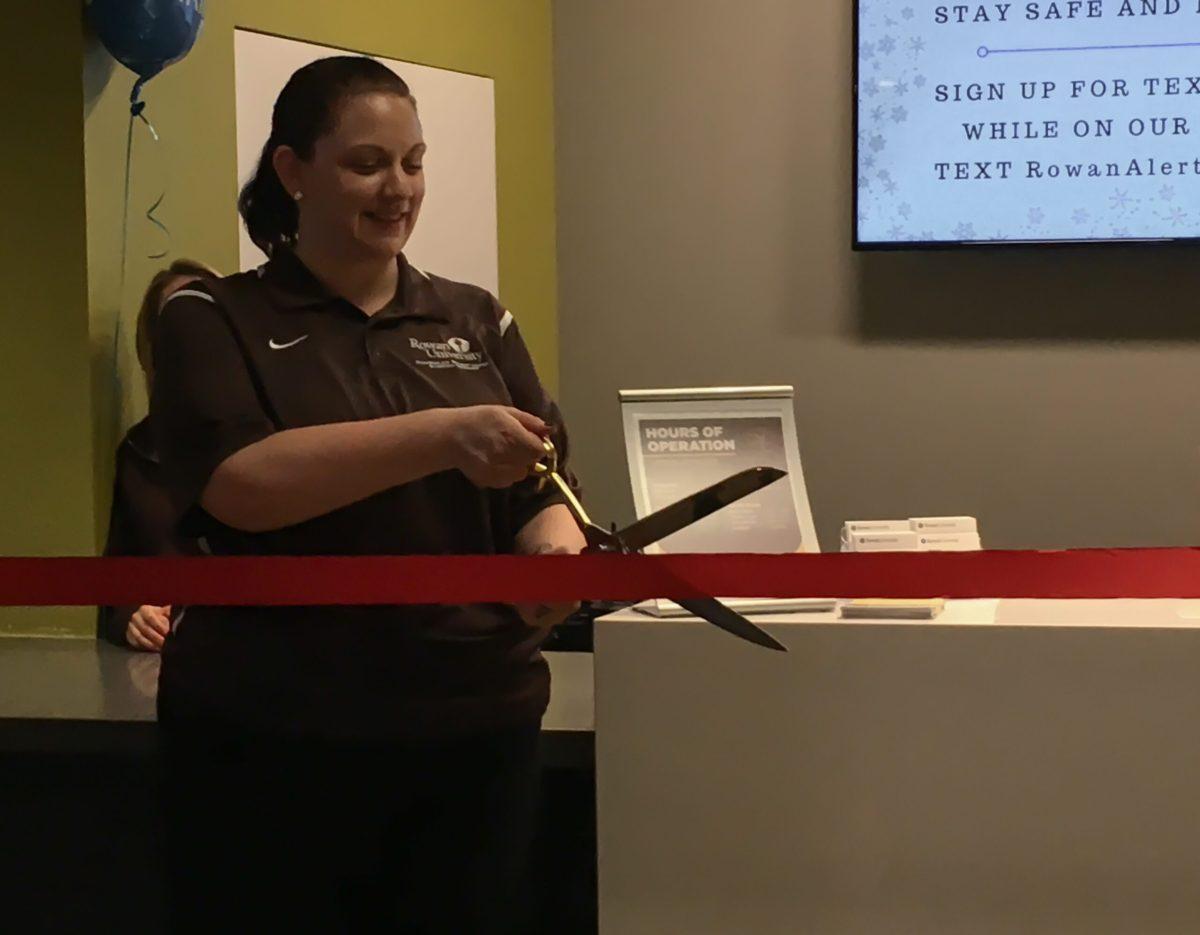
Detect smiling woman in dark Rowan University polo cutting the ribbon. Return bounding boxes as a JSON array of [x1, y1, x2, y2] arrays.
[[151, 56, 583, 935]]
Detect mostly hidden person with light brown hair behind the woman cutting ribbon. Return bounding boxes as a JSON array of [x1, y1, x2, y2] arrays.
[[97, 259, 220, 652]]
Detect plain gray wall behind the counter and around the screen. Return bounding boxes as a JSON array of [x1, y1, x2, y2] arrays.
[[554, 0, 1200, 550]]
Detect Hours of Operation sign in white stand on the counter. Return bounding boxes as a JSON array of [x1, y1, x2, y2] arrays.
[[620, 386, 828, 610]]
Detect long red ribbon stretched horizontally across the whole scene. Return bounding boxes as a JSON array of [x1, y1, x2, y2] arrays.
[[0, 549, 1200, 606]]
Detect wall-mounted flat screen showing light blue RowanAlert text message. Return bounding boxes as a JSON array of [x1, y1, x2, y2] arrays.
[[853, 0, 1200, 250]]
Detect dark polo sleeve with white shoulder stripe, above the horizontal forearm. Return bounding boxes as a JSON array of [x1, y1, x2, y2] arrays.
[[150, 284, 275, 537]]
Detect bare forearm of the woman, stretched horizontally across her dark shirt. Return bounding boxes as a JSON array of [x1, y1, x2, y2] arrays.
[[200, 409, 455, 532]]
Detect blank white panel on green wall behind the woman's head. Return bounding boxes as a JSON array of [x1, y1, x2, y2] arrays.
[[234, 29, 500, 295]]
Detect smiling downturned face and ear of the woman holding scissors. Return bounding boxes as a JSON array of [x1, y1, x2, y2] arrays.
[[283, 92, 425, 258]]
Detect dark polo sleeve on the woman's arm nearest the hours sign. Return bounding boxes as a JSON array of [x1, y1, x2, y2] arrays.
[[496, 305, 581, 540]]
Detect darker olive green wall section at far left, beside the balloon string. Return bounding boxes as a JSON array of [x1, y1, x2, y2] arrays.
[[0, 2, 94, 634]]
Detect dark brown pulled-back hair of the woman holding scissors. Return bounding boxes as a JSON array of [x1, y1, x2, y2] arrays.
[[238, 55, 416, 256]]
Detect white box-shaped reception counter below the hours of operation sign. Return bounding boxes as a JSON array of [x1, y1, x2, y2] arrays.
[[595, 600, 1200, 935]]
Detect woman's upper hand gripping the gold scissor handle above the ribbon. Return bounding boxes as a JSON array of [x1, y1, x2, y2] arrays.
[[446, 406, 550, 487]]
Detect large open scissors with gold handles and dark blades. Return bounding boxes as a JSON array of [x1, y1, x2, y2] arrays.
[[532, 438, 787, 652]]
